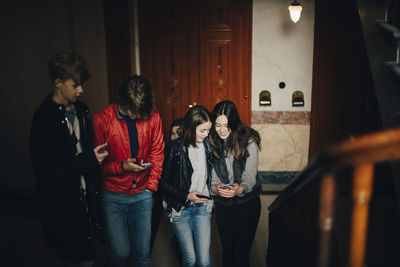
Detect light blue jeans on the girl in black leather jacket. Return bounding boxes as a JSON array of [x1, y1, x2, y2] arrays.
[[172, 204, 211, 267]]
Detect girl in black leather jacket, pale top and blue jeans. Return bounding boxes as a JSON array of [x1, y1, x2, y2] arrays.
[[159, 106, 213, 266]]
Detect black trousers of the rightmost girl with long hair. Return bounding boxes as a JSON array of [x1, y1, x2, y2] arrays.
[[215, 197, 261, 267]]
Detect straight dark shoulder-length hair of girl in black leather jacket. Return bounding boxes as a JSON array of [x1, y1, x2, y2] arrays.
[[182, 106, 211, 147]]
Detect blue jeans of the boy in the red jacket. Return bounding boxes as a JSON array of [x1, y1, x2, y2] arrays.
[[103, 190, 153, 267]]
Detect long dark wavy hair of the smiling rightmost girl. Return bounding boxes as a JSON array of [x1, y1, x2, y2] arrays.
[[209, 100, 261, 160]]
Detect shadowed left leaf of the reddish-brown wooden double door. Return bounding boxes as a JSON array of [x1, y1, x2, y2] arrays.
[[139, 0, 198, 136]]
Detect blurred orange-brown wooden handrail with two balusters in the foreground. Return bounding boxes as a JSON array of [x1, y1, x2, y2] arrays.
[[318, 129, 400, 267]]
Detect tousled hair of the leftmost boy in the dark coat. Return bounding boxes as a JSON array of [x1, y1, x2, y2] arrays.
[[48, 50, 90, 85]]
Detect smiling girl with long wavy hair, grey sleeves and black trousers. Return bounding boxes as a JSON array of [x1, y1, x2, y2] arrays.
[[210, 101, 261, 267]]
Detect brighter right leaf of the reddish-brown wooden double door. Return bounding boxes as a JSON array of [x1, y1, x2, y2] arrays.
[[199, 0, 252, 124]]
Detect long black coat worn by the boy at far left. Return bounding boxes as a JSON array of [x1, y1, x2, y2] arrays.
[[29, 95, 102, 261]]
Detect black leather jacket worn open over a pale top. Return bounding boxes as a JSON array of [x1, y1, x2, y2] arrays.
[[158, 138, 213, 217]]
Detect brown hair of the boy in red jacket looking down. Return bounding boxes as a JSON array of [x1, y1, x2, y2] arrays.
[[117, 75, 155, 119]]
